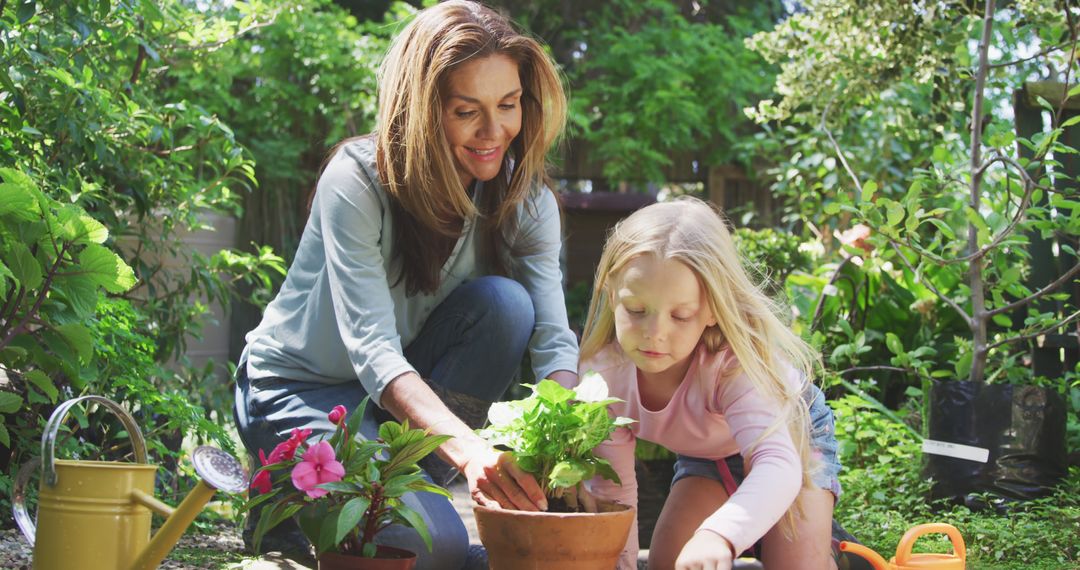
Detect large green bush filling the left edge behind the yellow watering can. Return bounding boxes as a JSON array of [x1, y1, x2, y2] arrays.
[[0, 0, 283, 516]]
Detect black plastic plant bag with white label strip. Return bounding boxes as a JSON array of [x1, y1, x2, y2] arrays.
[[923, 381, 1068, 506]]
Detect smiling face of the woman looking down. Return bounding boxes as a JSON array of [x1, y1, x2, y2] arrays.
[[443, 55, 522, 187]]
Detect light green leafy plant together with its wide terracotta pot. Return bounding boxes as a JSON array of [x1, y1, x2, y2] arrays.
[[473, 372, 634, 570]]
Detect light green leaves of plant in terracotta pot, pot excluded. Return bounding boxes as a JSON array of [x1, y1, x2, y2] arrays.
[[478, 371, 634, 508]]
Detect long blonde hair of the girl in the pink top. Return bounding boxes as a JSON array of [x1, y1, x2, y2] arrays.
[[581, 198, 820, 531]]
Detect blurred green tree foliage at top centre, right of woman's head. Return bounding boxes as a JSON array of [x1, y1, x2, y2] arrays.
[[499, 0, 782, 182]]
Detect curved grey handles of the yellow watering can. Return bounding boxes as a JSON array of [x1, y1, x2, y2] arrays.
[[11, 396, 147, 545]]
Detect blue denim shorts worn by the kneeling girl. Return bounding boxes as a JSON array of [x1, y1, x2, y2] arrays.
[[672, 384, 840, 499]]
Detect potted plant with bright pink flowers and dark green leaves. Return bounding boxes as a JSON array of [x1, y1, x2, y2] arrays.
[[243, 398, 450, 570]]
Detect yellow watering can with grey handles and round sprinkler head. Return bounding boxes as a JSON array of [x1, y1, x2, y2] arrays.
[[12, 396, 246, 570]]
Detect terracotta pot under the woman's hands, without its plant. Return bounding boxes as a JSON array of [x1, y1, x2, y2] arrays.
[[473, 503, 635, 570]]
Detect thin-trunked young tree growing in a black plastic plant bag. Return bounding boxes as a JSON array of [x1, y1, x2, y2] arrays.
[[822, 0, 1080, 503]]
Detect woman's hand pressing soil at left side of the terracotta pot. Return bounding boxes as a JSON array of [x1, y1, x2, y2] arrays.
[[461, 446, 548, 511]]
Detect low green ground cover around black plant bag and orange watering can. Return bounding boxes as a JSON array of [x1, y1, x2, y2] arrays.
[[831, 388, 1080, 570]]
